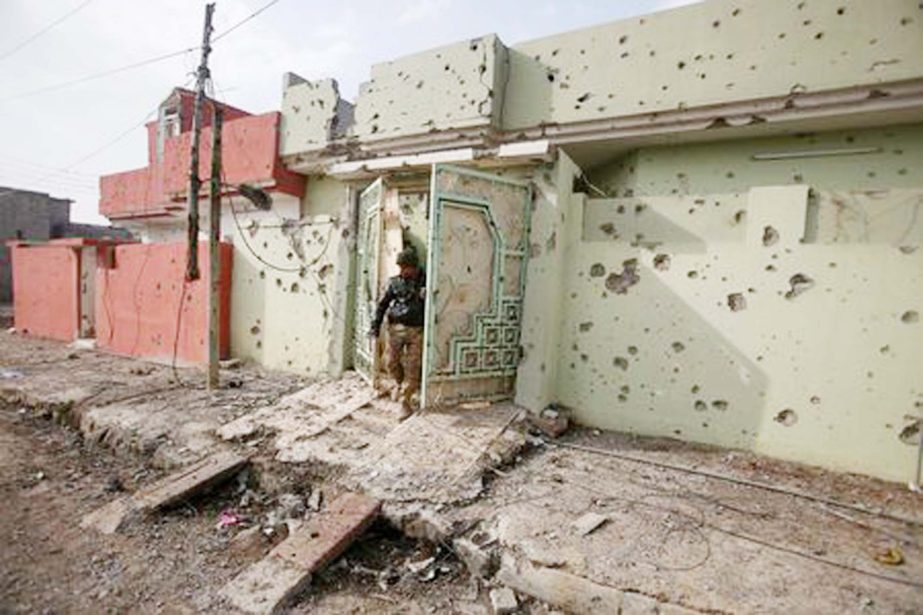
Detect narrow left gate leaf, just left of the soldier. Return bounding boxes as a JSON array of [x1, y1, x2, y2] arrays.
[[353, 179, 385, 382]]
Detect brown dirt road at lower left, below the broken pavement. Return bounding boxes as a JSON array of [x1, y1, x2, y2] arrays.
[[0, 404, 498, 613]]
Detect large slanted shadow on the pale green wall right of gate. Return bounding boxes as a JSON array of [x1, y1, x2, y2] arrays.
[[559, 244, 768, 447]]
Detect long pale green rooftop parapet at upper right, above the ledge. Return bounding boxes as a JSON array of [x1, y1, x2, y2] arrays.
[[504, 0, 923, 129]]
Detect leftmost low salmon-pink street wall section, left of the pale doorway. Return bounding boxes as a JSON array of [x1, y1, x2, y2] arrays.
[[10, 244, 80, 342]]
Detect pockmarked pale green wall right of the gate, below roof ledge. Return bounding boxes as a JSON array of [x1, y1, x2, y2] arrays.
[[540, 126, 923, 480]]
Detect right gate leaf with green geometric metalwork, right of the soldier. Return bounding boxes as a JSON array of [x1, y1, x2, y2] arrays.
[[423, 165, 532, 406]]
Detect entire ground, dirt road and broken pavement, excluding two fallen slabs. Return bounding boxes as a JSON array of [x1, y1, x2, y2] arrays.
[[0, 332, 923, 615]]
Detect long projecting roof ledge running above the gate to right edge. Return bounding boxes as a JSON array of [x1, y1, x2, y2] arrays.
[[282, 79, 923, 174]]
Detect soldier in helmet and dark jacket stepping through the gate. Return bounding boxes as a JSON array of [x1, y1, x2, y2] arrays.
[[370, 248, 426, 421]]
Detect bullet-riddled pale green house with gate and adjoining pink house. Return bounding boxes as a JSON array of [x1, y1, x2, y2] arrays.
[[14, 0, 923, 480]]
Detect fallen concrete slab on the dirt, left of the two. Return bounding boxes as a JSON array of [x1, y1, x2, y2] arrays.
[[80, 452, 249, 534]]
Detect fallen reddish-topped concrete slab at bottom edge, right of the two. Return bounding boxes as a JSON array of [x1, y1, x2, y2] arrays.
[[221, 493, 381, 613]]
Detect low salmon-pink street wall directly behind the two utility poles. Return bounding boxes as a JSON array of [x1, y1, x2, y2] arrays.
[[96, 242, 233, 364]]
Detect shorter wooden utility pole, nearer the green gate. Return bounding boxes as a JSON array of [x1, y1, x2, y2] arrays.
[[208, 105, 224, 391]]
